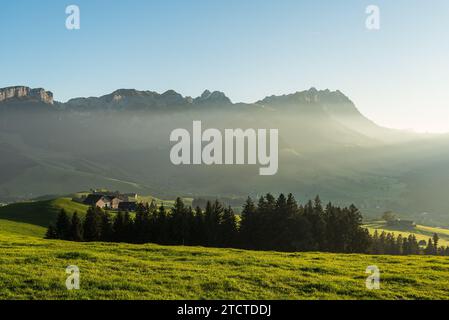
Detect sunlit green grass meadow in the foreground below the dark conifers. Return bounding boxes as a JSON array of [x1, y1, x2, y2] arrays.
[[0, 220, 449, 299]]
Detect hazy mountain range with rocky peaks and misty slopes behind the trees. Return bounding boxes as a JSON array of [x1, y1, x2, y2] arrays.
[[0, 86, 449, 224]]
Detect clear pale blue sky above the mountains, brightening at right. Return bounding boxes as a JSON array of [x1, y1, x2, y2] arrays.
[[0, 0, 449, 132]]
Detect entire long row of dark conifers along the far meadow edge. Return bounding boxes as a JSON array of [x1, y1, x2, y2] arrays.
[[47, 194, 449, 254]]
